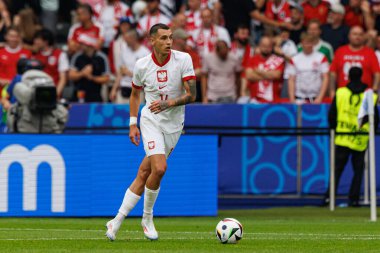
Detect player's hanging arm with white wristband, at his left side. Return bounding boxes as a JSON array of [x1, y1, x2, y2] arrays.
[[129, 87, 140, 146]]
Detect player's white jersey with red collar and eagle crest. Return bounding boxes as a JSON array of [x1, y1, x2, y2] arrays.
[[132, 50, 195, 134]]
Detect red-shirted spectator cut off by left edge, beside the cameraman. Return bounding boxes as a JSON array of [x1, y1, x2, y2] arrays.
[[0, 26, 32, 91]]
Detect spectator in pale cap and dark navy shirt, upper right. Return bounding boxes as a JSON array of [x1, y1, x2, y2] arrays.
[[321, 4, 349, 51]]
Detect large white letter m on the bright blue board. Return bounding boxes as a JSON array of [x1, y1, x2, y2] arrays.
[[0, 144, 66, 212]]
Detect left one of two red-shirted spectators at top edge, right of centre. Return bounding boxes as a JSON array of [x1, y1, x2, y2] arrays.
[[265, 0, 291, 22]]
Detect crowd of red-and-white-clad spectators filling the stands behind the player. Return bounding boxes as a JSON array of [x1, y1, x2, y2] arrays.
[[0, 0, 380, 105]]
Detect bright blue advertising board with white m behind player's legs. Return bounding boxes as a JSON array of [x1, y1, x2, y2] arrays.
[[0, 135, 218, 216]]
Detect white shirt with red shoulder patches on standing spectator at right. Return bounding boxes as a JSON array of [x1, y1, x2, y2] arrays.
[[287, 52, 329, 99]]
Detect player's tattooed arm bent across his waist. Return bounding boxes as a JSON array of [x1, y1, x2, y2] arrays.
[[149, 80, 197, 114]]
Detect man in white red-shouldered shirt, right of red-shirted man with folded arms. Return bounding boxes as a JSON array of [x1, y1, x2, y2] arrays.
[[287, 34, 329, 104]]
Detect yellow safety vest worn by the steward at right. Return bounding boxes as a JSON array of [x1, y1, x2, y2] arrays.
[[335, 87, 377, 151]]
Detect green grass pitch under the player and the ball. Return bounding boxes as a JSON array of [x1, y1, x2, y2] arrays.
[[0, 207, 380, 253]]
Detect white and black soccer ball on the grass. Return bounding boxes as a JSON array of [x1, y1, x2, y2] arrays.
[[215, 218, 243, 243]]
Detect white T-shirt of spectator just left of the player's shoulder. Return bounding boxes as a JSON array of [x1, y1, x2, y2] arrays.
[[120, 42, 150, 87]]
